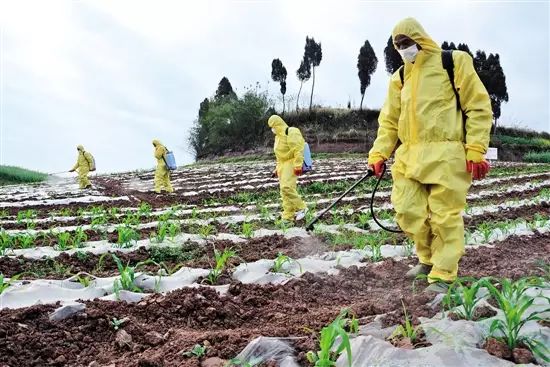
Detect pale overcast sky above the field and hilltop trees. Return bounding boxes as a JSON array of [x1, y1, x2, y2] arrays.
[[0, 0, 550, 172]]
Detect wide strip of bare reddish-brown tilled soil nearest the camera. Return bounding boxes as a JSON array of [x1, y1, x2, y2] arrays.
[[0, 233, 550, 367]]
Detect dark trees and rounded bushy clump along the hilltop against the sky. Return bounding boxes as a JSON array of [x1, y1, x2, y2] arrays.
[[189, 36, 508, 158]]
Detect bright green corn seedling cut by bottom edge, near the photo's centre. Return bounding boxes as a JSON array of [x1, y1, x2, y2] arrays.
[[306, 310, 359, 367]]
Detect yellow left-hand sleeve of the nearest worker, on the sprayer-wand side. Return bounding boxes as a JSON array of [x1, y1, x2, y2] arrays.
[[368, 70, 402, 164]]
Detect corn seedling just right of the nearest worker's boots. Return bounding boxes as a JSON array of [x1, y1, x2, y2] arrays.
[[442, 278, 486, 320]]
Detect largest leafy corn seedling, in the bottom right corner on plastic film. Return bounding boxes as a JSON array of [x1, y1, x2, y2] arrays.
[[485, 280, 550, 362]]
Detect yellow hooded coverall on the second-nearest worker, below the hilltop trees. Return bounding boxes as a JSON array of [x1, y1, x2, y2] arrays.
[[267, 115, 306, 221]]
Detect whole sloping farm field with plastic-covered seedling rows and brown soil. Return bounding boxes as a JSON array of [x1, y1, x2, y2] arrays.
[[0, 157, 550, 367]]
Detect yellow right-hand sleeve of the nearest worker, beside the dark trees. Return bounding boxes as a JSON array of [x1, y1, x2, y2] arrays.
[[453, 51, 493, 154]]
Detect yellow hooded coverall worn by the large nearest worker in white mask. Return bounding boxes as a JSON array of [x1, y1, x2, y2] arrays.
[[368, 18, 492, 282]]
